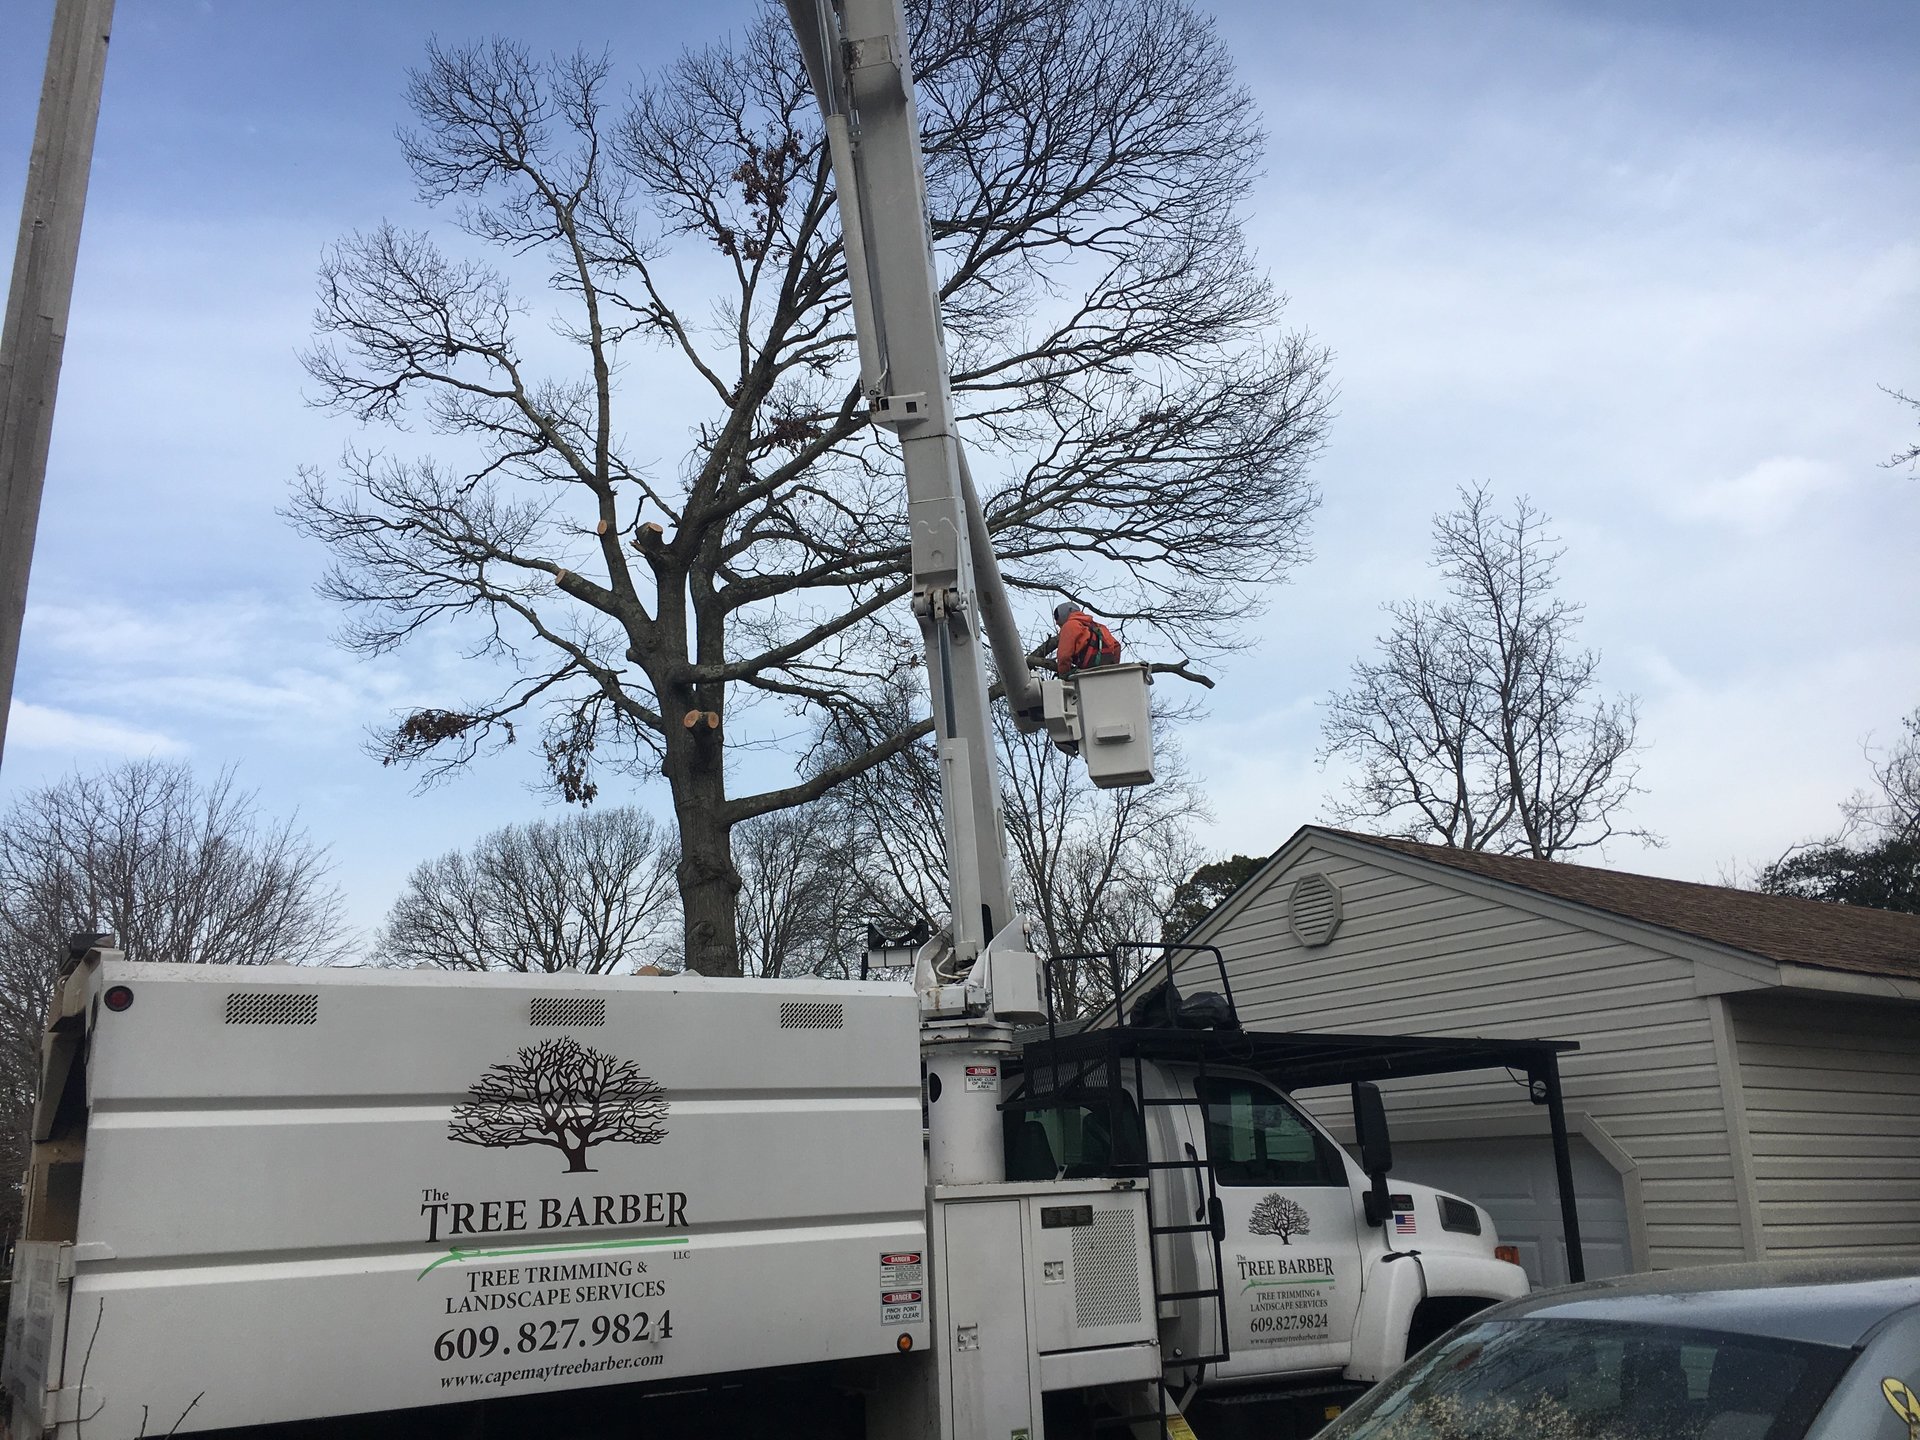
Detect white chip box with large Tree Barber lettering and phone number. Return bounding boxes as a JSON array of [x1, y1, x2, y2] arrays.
[[6, 960, 929, 1440]]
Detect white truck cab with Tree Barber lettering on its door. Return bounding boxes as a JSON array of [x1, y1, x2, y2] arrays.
[[1002, 960, 1526, 1432]]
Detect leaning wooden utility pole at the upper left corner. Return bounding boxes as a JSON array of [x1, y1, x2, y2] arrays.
[[0, 0, 113, 768]]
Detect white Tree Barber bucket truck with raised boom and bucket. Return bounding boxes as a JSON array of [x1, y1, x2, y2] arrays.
[[4, 0, 1578, 1440]]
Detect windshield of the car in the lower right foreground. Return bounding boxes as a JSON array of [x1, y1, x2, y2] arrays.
[[1323, 1319, 1851, 1440]]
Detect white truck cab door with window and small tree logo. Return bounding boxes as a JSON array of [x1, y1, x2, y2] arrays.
[[1190, 1073, 1361, 1379]]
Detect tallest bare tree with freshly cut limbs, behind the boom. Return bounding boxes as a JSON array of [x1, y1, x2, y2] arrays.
[[292, 0, 1331, 973]]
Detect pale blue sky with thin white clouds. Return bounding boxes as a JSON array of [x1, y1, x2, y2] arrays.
[[0, 0, 1920, 929]]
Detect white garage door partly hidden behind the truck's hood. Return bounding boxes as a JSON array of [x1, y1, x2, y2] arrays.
[[1394, 1135, 1632, 1284]]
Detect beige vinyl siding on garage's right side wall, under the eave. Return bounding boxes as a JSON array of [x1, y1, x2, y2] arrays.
[[1732, 995, 1920, 1258]]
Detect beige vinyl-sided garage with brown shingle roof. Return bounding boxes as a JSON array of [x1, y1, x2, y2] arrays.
[[1181, 826, 1920, 1284]]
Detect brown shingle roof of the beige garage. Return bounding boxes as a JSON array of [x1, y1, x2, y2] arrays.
[[1308, 826, 1920, 979]]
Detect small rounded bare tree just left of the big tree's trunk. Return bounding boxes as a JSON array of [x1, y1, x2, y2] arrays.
[[378, 808, 680, 975]]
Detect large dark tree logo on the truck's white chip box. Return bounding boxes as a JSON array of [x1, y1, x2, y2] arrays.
[[447, 1035, 666, 1173]]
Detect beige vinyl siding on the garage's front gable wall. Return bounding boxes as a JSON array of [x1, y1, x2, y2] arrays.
[[1188, 845, 1741, 1267]]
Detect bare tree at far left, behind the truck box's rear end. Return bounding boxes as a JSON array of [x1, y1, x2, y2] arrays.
[[0, 760, 349, 1225]]
